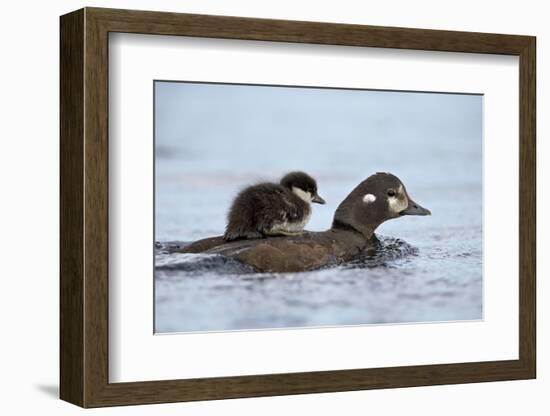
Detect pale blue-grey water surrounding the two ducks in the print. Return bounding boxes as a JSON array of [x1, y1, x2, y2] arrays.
[[155, 82, 483, 332]]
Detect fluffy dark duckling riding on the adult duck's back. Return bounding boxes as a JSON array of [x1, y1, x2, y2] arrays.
[[223, 172, 325, 241]]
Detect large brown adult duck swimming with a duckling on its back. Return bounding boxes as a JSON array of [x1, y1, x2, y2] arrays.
[[179, 173, 431, 273]]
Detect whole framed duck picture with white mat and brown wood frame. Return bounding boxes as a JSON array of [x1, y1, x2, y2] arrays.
[[60, 8, 536, 407]]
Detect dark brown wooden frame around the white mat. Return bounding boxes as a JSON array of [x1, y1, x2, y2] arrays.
[[60, 8, 536, 407]]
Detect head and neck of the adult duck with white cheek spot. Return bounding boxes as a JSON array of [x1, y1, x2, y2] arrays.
[[332, 173, 431, 239]]
